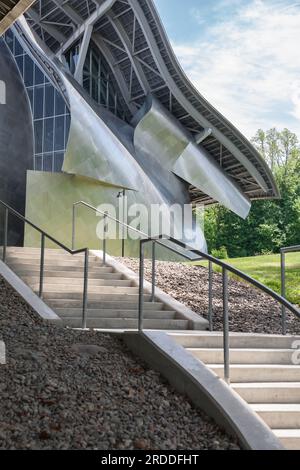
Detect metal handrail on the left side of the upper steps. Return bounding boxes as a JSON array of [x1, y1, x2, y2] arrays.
[[0, 200, 89, 329]]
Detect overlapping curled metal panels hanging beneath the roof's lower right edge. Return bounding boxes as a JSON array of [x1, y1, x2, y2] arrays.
[[133, 95, 251, 218]]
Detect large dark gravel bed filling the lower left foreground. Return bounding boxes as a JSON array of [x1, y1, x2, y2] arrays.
[[0, 278, 239, 450]]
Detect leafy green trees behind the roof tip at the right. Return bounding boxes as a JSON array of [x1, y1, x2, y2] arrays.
[[205, 128, 300, 257]]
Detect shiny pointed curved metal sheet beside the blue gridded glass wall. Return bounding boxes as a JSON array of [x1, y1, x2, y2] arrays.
[[63, 77, 140, 191]]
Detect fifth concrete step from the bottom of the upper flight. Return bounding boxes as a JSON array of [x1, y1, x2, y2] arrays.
[[23, 276, 132, 292]]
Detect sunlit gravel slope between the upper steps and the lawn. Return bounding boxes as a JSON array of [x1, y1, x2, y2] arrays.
[[117, 258, 300, 335]]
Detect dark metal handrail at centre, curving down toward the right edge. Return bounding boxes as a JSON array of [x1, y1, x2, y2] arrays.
[[138, 236, 300, 383]]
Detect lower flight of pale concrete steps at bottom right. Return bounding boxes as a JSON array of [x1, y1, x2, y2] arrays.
[[169, 332, 300, 450]]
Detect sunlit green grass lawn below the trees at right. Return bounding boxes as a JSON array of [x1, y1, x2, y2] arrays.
[[197, 253, 300, 305]]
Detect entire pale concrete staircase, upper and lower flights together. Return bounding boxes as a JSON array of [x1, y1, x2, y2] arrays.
[[7, 247, 300, 450]]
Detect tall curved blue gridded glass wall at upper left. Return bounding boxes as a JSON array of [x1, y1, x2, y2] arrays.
[[5, 31, 70, 172]]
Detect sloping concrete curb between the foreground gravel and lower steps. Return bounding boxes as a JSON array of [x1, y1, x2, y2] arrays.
[[122, 331, 284, 450]]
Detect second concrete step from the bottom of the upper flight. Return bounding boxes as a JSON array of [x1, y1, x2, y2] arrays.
[[55, 308, 176, 320]]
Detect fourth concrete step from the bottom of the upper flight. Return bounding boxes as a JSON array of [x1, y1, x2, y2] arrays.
[[40, 286, 142, 302]]
